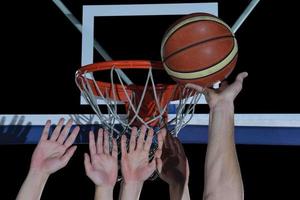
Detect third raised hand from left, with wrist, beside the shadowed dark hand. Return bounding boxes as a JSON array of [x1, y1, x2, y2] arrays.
[[120, 126, 163, 200]]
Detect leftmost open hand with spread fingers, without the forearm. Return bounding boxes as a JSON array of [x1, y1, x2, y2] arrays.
[[30, 119, 79, 175]]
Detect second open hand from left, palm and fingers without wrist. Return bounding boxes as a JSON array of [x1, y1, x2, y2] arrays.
[[84, 129, 118, 187]]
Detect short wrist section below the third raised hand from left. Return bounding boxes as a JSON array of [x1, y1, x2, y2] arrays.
[[119, 182, 143, 200]]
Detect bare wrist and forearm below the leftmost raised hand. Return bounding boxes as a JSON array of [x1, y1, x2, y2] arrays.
[[16, 171, 49, 200]]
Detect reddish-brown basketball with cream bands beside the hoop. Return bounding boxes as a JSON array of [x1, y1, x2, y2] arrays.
[[161, 13, 238, 87]]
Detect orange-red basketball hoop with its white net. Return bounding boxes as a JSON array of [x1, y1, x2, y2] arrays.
[[75, 60, 201, 139]]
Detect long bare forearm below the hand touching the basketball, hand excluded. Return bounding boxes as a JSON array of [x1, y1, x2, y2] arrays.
[[204, 102, 243, 200]]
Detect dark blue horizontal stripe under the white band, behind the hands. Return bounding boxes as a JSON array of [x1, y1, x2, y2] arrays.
[[0, 125, 300, 145]]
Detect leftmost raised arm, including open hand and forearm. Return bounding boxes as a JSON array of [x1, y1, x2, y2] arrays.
[[16, 119, 79, 200]]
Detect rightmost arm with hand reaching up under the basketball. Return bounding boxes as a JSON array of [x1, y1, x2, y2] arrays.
[[187, 72, 248, 200]]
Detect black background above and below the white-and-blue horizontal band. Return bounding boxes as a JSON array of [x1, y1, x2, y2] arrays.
[[0, 0, 300, 200]]
